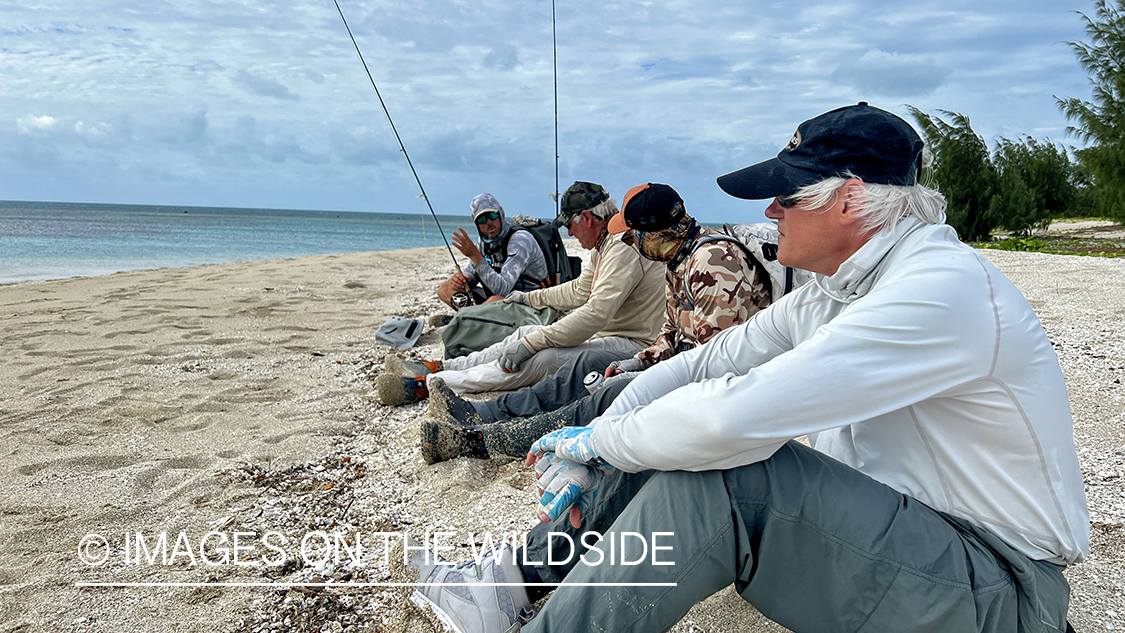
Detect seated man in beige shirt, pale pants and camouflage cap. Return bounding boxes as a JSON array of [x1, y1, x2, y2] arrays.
[[377, 182, 664, 405]]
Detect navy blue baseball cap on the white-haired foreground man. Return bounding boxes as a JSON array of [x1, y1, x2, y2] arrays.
[[718, 101, 925, 200]]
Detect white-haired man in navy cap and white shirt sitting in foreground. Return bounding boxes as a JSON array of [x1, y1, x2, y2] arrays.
[[414, 102, 1089, 633]]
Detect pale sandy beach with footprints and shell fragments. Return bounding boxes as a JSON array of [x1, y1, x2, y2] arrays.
[[0, 240, 1125, 633]]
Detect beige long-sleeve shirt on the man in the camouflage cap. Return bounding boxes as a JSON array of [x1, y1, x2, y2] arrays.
[[523, 235, 665, 352]]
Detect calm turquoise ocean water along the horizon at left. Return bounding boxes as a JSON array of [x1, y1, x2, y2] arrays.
[[0, 200, 471, 283]]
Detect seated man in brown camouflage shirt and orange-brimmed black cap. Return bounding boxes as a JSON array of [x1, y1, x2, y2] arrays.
[[422, 183, 771, 463]]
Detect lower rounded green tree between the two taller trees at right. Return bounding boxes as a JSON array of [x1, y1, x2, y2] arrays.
[[989, 137, 1078, 235]]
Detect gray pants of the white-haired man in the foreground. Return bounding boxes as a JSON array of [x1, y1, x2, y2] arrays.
[[527, 442, 1069, 633]]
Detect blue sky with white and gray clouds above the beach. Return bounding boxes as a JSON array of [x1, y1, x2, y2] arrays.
[[0, 0, 1092, 221]]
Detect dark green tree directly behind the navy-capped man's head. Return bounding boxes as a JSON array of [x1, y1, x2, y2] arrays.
[[907, 106, 1000, 242]]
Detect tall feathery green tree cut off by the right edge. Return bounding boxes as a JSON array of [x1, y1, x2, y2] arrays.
[[1058, 0, 1125, 221]]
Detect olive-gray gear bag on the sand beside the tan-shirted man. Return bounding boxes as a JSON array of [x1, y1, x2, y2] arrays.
[[441, 301, 559, 359]]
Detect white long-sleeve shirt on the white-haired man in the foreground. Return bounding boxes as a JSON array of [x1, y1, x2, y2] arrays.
[[593, 218, 1089, 564]]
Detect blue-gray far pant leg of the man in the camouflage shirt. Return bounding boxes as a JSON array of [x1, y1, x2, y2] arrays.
[[474, 349, 633, 422]]
